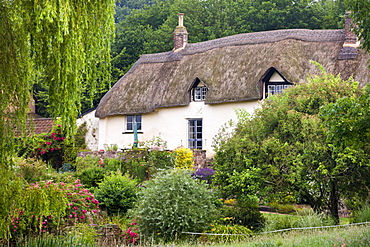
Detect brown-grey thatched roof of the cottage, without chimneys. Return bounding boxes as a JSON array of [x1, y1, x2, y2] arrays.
[[96, 29, 370, 118]]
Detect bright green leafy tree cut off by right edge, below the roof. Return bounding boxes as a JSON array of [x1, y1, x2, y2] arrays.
[[321, 84, 370, 206]]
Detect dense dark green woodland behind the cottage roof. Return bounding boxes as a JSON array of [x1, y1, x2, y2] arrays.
[[34, 0, 346, 117]]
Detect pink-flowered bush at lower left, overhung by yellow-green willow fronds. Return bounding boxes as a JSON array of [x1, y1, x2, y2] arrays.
[[10, 180, 99, 237]]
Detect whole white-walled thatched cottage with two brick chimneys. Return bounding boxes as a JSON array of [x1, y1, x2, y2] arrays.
[[95, 14, 370, 157]]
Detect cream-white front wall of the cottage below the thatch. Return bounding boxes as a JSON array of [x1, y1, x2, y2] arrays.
[[98, 101, 260, 157]]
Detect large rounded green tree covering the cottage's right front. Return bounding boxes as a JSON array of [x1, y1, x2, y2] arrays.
[[214, 63, 369, 220]]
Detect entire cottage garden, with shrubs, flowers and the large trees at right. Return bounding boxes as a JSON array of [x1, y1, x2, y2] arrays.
[[0, 70, 370, 247]]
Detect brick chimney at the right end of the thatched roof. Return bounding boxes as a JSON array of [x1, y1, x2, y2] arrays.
[[338, 12, 360, 60]]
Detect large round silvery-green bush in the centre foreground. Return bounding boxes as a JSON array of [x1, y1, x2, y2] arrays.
[[131, 169, 216, 241]]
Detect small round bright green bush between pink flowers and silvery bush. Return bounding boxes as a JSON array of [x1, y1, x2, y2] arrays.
[[94, 172, 137, 215]]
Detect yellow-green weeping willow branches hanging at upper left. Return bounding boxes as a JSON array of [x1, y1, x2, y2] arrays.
[[0, 0, 115, 168]]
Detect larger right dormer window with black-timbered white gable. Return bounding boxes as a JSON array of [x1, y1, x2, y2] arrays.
[[262, 67, 294, 98]]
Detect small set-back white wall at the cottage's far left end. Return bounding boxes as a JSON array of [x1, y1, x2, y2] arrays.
[[76, 110, 99, 151]]
